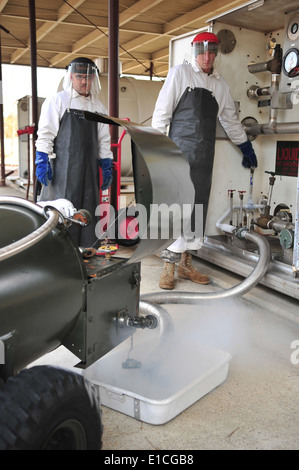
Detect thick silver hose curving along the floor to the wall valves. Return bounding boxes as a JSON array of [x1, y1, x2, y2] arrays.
[[141, 231, 271, 304]]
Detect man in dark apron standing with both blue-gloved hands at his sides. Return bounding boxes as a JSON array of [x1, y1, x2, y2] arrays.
[[35, 57, 113, 247]]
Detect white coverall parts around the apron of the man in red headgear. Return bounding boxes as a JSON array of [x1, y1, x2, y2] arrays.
[[152, 60, 247, 253]]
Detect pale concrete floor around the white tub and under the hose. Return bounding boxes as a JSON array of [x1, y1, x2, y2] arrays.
[[0, 179, 299, 451]]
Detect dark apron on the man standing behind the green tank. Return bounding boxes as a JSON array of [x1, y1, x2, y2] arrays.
[[40, 109, 99, 247]]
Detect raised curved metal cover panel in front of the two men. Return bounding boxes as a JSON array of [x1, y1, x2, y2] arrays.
[[82, 111, 194, 263]]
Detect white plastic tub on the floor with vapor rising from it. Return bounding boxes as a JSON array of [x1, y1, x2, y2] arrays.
[[83, 330, 231, 425]]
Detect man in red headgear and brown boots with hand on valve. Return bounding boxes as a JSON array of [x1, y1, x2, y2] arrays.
[[152, 32, 257, 289]]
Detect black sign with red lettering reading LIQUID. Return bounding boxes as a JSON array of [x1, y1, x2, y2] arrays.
[[275, 141, 299, 176]]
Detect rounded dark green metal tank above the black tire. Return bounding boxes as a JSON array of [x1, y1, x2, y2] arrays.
[[0, 198, 86, 375]]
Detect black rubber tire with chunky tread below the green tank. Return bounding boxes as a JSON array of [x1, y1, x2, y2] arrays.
[[0, 366, 102, 450]]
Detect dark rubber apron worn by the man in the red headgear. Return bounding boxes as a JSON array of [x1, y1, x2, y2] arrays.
[[169, 88, 218, 233]]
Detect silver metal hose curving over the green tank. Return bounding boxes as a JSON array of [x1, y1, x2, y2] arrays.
[[0, 197, 59, 262]]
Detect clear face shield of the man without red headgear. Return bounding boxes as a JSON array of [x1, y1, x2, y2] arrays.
[[63, 62, 101, 95]]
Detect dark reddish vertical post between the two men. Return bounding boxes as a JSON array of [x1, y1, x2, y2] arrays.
[[108, 0, 119, 208]]
